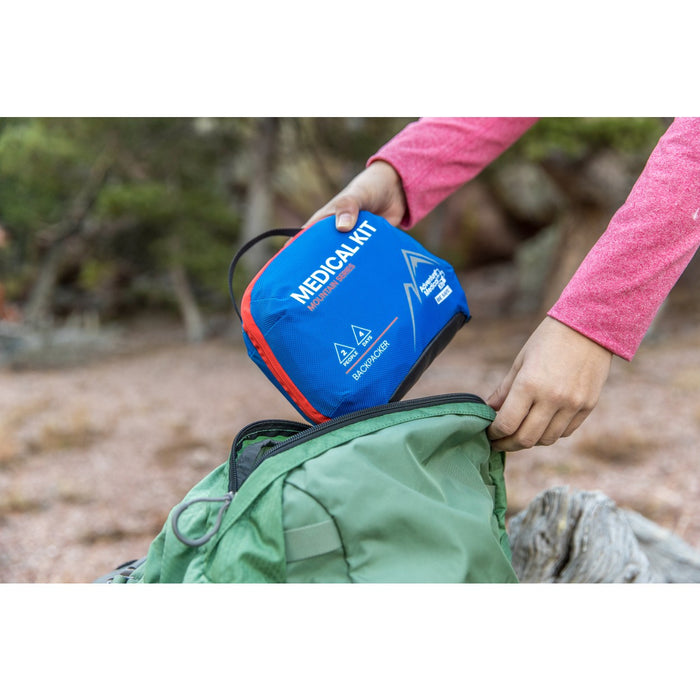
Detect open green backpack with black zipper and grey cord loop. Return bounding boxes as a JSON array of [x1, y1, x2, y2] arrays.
[[101, 394, 517, 583]]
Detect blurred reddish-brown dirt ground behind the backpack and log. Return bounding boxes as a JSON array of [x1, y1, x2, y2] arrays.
[[0, 270, 700, 583]]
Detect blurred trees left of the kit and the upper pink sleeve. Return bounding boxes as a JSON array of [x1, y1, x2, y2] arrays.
[[0, 117, 416, 340]]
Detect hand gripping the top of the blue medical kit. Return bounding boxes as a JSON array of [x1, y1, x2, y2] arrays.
[[303, 160, 406, 231]]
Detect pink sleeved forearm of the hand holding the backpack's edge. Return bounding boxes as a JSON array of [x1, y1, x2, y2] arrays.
[[549, 119, 700, 360]]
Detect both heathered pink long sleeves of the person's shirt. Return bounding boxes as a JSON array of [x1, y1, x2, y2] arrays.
[[369, 117, 700, 360]]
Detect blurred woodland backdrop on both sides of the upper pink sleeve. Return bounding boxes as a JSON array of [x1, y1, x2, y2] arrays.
[[0, 117, 667, 340]]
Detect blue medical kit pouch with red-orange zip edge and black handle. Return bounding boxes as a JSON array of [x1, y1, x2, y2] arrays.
[[229, 211, 470, 423]]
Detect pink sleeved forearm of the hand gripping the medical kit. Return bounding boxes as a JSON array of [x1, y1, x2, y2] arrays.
[[368, 117, 537, 228]]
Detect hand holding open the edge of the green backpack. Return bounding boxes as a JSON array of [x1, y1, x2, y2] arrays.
[[487, 317, 612, 451]]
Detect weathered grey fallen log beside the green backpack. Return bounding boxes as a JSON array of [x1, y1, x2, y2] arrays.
[[508, 486, 700, 583]]
